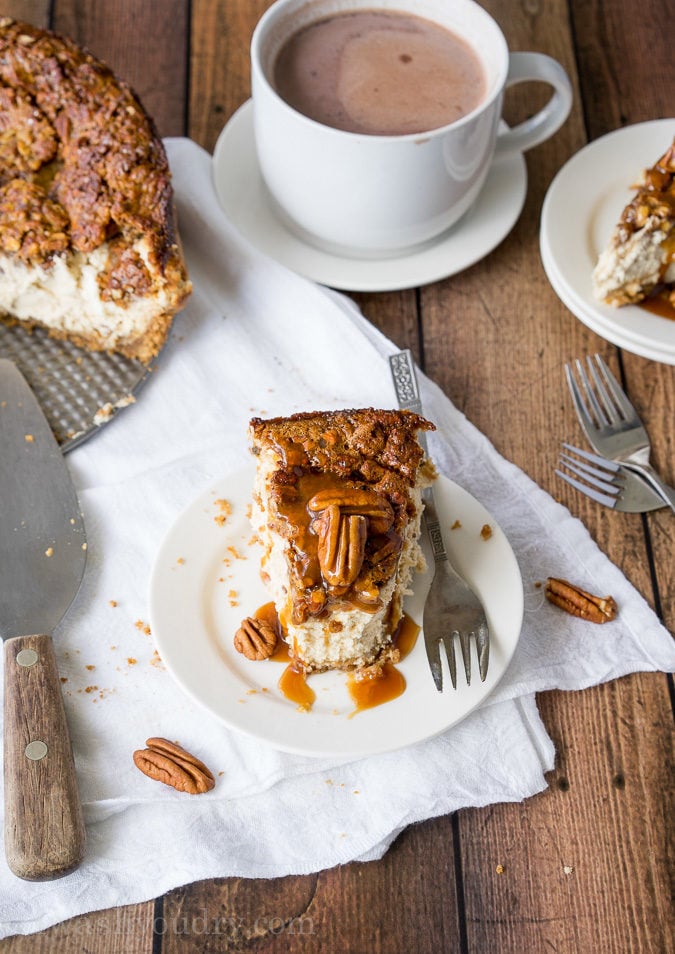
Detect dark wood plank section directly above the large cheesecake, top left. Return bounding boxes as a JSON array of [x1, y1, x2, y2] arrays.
[[52, 0, 189, 136]]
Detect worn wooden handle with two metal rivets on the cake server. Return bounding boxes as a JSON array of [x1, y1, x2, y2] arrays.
[[5, 636, 85, 881]]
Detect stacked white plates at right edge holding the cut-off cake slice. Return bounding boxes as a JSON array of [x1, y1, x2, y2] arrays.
[[539, 119, 675, 364]]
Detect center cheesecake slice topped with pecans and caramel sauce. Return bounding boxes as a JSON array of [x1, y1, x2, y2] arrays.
[[249, 408, 434, 672]]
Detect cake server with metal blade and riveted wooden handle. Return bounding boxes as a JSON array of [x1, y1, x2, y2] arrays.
[[0, 359, 86, 881]]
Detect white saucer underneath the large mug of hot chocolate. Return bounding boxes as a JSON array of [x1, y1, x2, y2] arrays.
[[213, 100, 527, 291]]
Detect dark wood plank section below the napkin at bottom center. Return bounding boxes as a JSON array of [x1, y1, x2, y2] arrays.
[[163, 817, 458, 954]]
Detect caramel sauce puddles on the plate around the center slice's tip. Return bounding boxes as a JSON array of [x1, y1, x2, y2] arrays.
[[255, 603, 420, 719]]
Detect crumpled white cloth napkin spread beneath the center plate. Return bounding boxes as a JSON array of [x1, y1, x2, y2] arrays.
[[0, 139, 675, 936]]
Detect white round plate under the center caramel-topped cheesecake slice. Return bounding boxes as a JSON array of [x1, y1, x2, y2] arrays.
[[150, 468, 523, 757]]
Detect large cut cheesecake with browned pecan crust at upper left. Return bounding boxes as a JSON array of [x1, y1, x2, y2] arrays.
[[0, 18, 191, 363]]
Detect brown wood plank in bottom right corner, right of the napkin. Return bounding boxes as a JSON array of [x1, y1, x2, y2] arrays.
[[461, 673, 673, 954]]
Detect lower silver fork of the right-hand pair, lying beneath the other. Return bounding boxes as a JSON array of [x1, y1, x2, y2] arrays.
[[556, 444, 665, 513]]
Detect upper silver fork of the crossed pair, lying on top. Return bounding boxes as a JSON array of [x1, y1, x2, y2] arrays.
[[565, 354, 675, 513]]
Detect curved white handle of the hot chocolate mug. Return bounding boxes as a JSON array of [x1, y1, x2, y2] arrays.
[[495, 53, 572, 156]]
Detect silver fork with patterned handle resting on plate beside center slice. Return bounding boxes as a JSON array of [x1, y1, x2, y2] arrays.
[[389, 350, 490, 692]]
